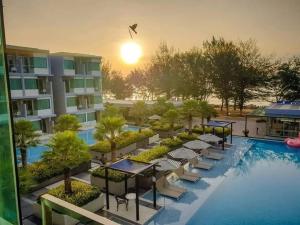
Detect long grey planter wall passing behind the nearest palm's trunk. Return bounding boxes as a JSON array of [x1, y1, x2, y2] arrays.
[[31, 161, 91, 192]]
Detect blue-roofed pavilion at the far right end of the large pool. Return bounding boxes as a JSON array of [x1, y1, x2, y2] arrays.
[[245, 101, 300, 137]]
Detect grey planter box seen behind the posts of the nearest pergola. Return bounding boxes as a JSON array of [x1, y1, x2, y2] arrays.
[[91, 176, 135, 195]]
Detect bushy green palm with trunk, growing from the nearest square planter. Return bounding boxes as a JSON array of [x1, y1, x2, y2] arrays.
[[43, 131, 90, 195]]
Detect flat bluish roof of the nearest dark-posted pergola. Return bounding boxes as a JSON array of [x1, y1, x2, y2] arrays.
[[108, 159, 153, 174]]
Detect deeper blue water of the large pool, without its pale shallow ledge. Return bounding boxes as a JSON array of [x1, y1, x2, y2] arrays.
[[187, 140, 300, 225]]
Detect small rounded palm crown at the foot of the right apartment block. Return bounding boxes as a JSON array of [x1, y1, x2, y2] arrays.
[[54, 114, 80, 132]]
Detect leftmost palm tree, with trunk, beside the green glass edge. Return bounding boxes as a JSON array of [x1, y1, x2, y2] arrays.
[[14, 120, 40, 168]]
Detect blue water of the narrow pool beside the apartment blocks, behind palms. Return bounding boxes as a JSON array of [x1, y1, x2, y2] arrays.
[[17, 125, 140, 163]]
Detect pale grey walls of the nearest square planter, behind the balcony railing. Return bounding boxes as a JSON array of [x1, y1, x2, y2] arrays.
[[32, 194, 104, 225]]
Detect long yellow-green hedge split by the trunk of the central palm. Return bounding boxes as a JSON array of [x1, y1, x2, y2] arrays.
[[90, 129, 154, 153]]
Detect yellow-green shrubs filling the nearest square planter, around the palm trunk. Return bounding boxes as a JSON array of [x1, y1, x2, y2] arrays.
[[48, 180, 101, 207]]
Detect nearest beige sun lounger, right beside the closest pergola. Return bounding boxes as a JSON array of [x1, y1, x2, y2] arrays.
[[156, 176, 187, 199]]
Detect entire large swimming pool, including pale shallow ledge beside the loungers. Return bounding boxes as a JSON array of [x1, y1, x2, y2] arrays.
[[145, 138, 300, 225]]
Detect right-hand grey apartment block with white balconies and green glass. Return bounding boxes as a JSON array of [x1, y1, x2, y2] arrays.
[[50, 52, 103, 127]]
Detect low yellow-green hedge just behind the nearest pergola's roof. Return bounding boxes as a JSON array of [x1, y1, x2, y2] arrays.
[[131, 146, 170, 162]]
